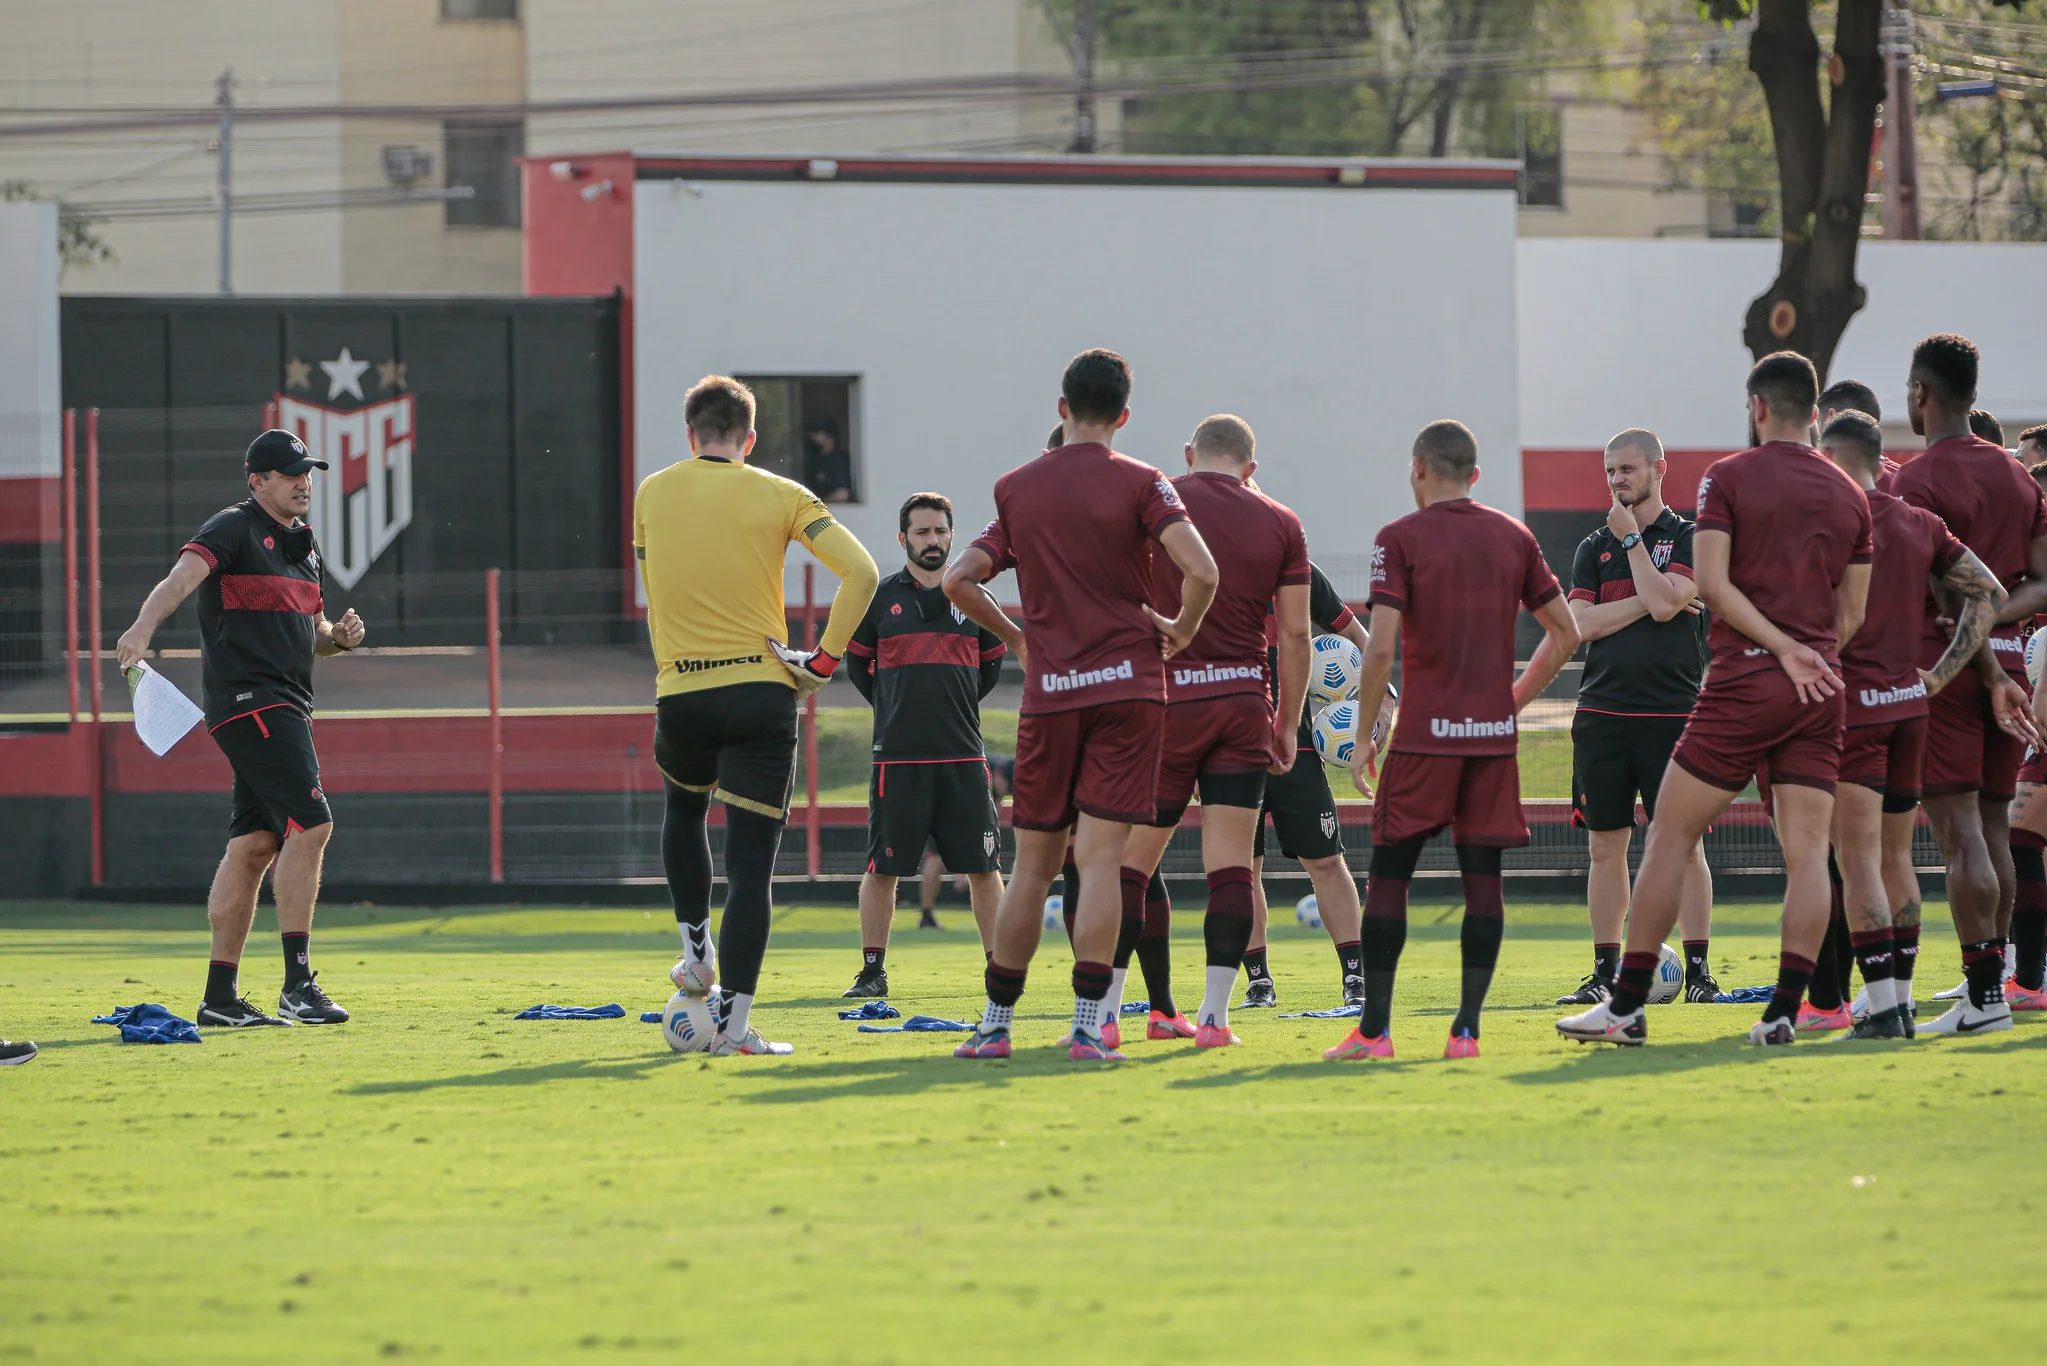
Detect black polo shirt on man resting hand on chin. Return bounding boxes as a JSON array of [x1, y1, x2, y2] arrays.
[[1570, 508, 1709, 717]]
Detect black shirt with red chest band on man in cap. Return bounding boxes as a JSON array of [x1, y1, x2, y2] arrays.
[[182, 498, 321, 729]]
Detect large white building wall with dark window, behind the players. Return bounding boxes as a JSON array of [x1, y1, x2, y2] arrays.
[[635, 180, 1521, 593]]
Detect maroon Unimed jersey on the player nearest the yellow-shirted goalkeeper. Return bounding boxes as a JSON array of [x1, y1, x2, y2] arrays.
[[974, 442, 1187, 713]]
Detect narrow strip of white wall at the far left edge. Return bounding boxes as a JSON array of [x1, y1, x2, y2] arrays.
[[0, 203, 63, 479]]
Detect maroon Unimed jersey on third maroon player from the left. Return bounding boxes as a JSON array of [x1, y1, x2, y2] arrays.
[[1371, 498, 1562, 756]]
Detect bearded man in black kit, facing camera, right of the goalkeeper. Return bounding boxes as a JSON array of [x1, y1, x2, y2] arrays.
[[845, 494, 1005, 997]]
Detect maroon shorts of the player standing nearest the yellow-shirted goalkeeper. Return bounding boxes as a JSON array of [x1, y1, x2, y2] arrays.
[[1011, 700, 1165, 829]]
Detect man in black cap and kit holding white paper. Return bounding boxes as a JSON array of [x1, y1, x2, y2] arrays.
[[117, 430, 364, 1028]]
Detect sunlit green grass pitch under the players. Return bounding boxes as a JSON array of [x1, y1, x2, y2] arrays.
[[0, 892, 2047, 1364]]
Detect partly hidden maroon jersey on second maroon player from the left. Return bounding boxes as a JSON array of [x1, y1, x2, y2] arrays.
[[1152, 469, 1308, 702]]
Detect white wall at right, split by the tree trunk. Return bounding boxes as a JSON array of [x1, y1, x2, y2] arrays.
[[1515, 240, 2047, 449]]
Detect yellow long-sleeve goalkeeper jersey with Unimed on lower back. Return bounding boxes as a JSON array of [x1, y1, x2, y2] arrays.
[[633, 457, 880, 696]]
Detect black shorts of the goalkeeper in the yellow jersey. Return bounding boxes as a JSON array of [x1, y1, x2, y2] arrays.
[[653, 682, 796, 821]]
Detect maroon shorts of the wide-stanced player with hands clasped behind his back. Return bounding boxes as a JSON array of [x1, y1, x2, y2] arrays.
[[1670, 664, 1848, 793]]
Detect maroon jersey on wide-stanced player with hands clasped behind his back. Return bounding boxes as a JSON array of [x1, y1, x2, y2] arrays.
[[1699, 440, 1873, 688]]
